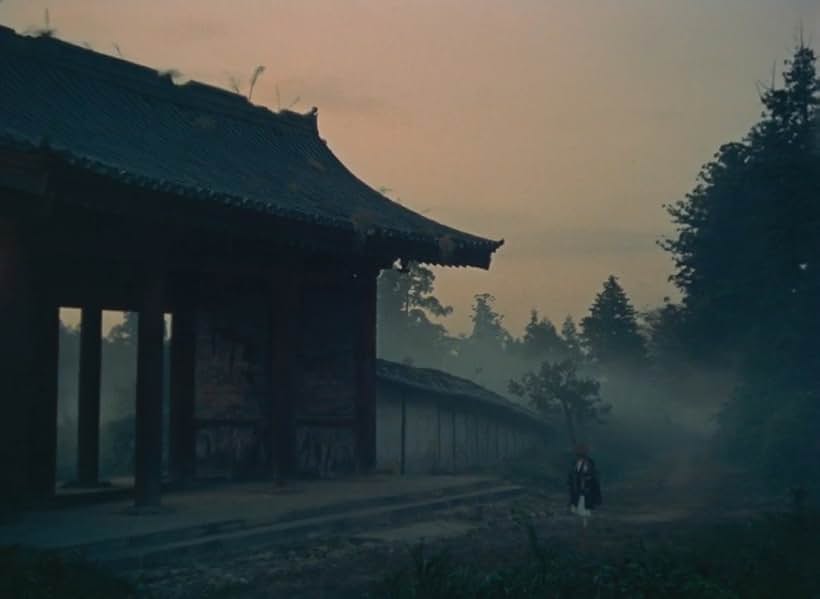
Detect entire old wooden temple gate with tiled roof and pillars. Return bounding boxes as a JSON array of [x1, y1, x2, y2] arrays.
[[0, 27, 502, 507]]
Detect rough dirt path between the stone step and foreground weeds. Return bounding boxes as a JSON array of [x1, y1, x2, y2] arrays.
[[131, 467, 772, 599]]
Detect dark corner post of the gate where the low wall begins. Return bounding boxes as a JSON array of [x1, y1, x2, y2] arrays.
[[355, 268, 378, 472]]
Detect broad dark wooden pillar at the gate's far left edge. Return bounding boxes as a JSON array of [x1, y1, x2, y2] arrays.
[[0, 218, 59, 505]]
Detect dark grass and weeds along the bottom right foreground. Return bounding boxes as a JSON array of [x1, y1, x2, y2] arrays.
[[373, 509, 820, 599]]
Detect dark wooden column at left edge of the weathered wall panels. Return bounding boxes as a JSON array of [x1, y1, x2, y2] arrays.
[[168, 304, 196, 482]]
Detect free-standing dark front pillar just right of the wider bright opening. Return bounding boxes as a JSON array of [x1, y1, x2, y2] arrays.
[[134, 272, 165, 507]]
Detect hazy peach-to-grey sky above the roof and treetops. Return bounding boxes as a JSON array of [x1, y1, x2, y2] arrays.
[[0, 0, 820, 334]]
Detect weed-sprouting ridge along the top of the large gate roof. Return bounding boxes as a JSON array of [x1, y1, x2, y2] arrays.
[[0, 25, 319, 138]]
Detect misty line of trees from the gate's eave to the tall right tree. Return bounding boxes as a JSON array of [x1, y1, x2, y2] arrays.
[[379, 42, 820, 488]]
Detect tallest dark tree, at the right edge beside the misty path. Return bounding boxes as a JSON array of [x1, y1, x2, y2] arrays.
[[663, 43, 820, 482]]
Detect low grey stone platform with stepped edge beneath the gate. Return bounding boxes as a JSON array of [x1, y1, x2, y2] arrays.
[[0, 476, 521, 569]]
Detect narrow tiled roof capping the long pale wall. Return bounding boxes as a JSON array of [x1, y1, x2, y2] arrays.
[[376, 360, 548, 426]]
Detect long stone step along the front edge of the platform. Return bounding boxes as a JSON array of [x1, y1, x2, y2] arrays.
[[78, 484, 524, 570]]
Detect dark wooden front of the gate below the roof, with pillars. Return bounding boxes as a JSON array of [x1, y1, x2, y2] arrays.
[[0, 190, 387, 505]]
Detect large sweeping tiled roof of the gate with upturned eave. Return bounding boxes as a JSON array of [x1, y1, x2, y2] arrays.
[[0, 27, 503, 268]]
